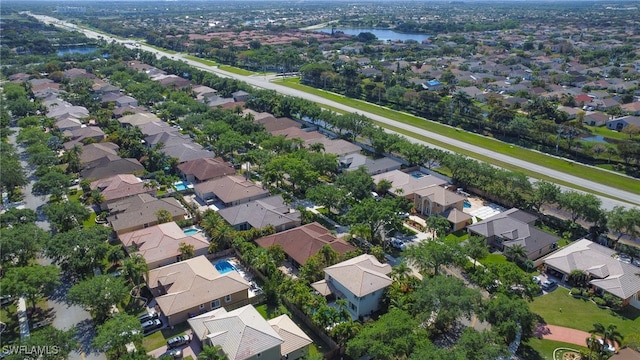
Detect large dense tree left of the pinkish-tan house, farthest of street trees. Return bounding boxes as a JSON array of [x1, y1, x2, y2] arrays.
[[44, 226, 110, 277]]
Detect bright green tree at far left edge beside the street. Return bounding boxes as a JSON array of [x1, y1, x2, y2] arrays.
[[0, 265, 60, 311]]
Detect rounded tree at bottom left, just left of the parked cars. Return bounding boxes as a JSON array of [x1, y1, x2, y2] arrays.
[[93, 313, 143, 359]]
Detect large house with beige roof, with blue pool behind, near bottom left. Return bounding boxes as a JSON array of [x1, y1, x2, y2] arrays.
[[147, 256, 249, 326]]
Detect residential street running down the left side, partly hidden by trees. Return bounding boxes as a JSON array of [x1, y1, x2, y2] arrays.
[[9, 127, 106, 360]]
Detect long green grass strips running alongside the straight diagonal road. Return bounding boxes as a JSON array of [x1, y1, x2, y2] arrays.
[[278, 79, 640, 195]]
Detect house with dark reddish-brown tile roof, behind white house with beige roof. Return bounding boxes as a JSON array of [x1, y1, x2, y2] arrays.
[[256, 222, 356, 267]]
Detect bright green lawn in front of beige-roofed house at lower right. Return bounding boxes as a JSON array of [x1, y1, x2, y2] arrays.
[[530, 287, 640, 336]]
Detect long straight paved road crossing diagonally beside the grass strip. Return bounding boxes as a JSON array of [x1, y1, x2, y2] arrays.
[[28, 15, 640, 209]]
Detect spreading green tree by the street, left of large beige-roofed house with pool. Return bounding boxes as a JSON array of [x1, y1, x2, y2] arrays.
[[67, 275, 129, 323]]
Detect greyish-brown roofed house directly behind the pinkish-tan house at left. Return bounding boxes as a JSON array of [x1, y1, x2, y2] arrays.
[[107, 194, 188, 234]]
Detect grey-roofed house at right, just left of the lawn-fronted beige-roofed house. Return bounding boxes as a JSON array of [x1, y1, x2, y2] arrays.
[[467, 208, 560, 260]]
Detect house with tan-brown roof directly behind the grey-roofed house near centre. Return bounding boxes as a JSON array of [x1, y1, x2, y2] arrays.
[[193, 175, 269, 206]]
